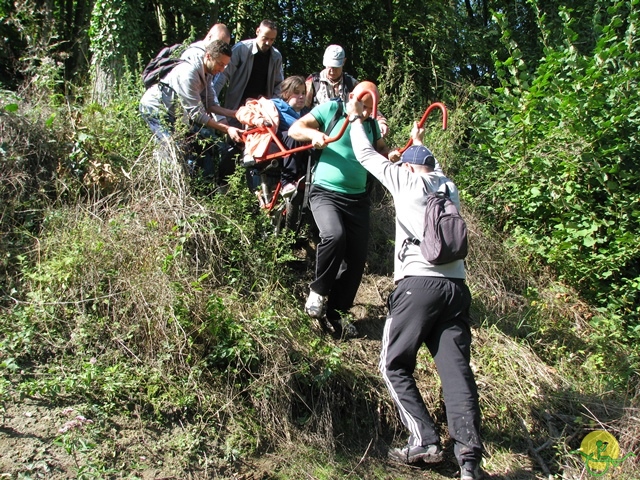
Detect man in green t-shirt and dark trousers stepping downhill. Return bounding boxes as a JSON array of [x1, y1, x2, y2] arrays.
[[289, 82, 388, 336]]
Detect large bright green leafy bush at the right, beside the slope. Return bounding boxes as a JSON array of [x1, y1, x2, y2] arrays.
[[466, 2, 640, 372]]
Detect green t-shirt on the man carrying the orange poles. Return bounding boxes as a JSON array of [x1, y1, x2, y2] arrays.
[[311, 101, 380, 194]]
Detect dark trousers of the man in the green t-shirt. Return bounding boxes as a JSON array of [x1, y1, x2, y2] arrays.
[[309, 185, 370, 320]]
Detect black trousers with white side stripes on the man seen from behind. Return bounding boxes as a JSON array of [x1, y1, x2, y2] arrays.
[[379, 277, 482, 465]]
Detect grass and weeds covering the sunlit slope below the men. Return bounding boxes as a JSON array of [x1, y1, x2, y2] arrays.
[[0, 88, 640, 479]]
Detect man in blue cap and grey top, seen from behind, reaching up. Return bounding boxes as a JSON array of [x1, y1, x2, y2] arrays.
[[347, 101, 482, 480]]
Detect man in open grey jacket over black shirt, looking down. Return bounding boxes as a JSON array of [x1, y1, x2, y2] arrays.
[[214, 20, 284, 117]]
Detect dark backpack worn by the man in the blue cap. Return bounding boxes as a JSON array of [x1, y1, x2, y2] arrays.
[[408, 183, 468, 265]]
